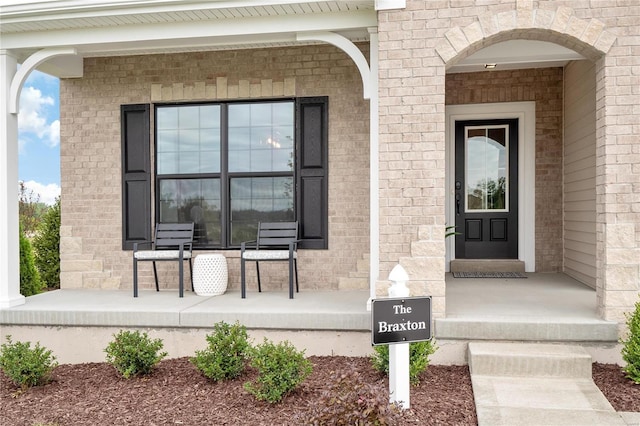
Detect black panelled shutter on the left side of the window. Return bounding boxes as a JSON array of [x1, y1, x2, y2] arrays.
[[120, 104, 151, 250]]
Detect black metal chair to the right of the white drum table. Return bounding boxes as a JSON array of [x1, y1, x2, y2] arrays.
[[240, 222, 299, 299]]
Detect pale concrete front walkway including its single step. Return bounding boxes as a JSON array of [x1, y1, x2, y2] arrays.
[[469, 342, 640, 426]]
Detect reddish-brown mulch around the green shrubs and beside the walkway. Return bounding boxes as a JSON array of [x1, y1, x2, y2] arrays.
[[0, 356, 640, 426]]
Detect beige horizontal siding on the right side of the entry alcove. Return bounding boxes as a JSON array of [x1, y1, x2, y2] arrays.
[[563, 61, 596, 288]]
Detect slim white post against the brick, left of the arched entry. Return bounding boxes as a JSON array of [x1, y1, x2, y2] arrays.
[[369, 28, 380, 300]]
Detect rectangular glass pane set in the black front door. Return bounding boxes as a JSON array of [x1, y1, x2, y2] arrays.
[[465, 126, 509, 212]]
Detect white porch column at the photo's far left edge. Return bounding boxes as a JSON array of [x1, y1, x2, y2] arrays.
[[0, 50, 25, 309]]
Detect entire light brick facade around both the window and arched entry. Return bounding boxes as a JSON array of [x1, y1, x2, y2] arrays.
[[61, 0, 640, 321]]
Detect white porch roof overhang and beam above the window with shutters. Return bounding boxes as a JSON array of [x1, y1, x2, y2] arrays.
[[0, 0, 377, 77]]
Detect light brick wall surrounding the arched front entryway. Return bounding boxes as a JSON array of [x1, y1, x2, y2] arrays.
[[378, 0, 640, 322]]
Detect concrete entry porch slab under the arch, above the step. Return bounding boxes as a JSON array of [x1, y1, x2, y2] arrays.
[[434, 273, 622, 364]]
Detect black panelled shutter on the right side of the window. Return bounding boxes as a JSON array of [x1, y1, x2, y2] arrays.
[[296, 97, 329, 249]]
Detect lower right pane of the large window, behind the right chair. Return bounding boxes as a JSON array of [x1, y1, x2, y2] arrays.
[[231, 176, 294, 245]]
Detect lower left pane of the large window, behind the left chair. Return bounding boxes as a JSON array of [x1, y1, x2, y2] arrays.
[[160, 179, 221, 246]]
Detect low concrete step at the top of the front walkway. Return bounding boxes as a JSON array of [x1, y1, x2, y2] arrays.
[[469, 342, 591, 379]]
